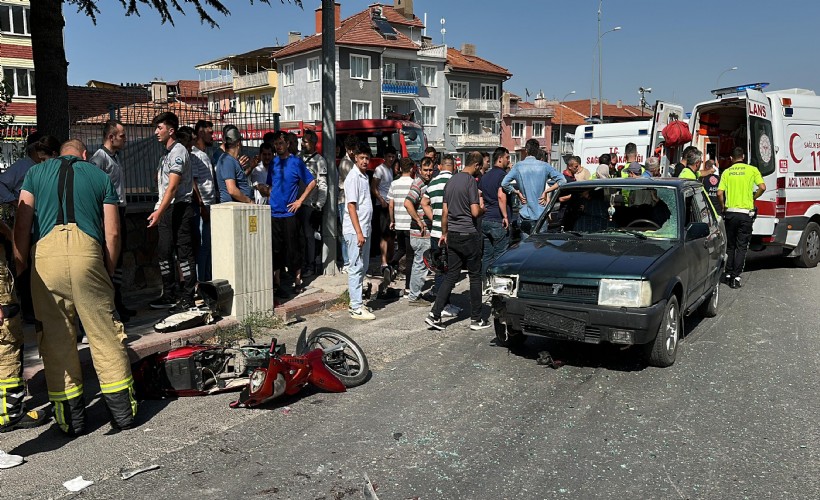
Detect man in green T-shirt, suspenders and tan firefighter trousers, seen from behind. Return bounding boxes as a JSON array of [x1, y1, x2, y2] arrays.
[[14, 139, 137, 435]]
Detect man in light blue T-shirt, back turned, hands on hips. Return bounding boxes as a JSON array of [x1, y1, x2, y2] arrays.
[[501, 139, 567, 238]]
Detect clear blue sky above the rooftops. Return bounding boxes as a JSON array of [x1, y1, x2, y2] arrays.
[[64, 0, 820, 110]]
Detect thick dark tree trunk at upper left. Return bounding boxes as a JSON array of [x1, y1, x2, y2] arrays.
[[31, 0, 69, 141]]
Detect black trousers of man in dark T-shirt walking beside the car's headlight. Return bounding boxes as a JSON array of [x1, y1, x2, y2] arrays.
[[432, 232, 482, 321]]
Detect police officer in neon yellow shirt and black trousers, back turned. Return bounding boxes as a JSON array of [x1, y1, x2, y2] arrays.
[[718, 148, 766, 288]]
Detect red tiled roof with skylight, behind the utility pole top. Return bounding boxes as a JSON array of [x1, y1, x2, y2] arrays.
[[273, 6, 420, 59]]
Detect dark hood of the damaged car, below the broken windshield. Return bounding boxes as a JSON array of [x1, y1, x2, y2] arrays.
[[489, 234, 674, 280]]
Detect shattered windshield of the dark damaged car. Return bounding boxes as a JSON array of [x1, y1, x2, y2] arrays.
[[538, 183, 680, 239]]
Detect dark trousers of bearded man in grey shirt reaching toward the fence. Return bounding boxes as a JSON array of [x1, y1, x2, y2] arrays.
[[157, 203, 196, 300]]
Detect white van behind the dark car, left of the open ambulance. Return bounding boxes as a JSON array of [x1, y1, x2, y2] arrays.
[[573, 120, 652, 174]]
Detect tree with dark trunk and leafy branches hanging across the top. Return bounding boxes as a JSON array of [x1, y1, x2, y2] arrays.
[[31, 0, 302, 140]]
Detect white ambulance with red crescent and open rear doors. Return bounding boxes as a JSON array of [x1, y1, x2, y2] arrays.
[[651, 83, 820, 267]]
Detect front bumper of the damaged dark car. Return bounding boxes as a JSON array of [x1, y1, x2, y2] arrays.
[[491, 295, 666, 344]]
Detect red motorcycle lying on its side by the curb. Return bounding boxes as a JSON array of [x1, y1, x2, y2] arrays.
[[134, 328, 370, 408]]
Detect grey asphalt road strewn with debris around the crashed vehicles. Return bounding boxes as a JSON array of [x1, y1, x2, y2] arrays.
[[0, 250, 820, 500]]
